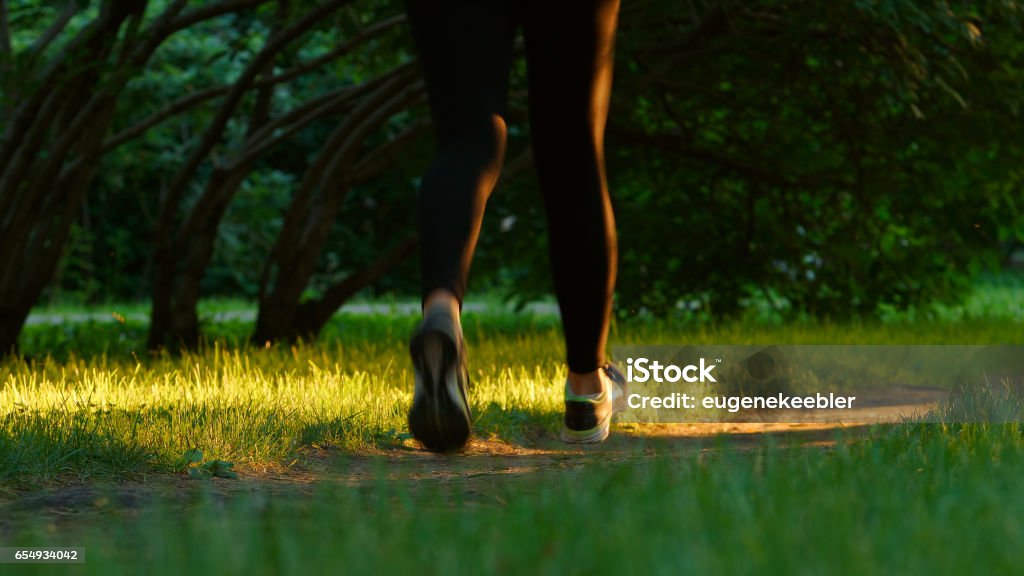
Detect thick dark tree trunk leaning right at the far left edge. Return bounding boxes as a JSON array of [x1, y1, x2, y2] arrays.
[[0, 3, 141, 354]]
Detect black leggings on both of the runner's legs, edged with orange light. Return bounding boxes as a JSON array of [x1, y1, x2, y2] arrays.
[[407, 0, 618, 373]]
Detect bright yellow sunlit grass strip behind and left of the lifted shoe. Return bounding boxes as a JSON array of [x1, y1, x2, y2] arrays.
[[0, 338, 561, 480]]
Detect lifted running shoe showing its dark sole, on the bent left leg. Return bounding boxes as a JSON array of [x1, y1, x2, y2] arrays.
[[409, 311, 471, 452]]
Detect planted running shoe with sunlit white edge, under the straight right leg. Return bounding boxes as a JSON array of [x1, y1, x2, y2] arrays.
[[562, 364, 627, 444]]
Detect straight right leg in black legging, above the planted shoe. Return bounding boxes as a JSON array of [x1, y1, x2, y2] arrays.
[[523, 0, 618, 381]]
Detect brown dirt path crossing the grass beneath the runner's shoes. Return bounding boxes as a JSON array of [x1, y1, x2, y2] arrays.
[[0, 416, 865, 537]]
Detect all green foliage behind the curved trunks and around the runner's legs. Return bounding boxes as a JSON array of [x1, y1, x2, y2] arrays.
[[14, 0, 1024, 318]]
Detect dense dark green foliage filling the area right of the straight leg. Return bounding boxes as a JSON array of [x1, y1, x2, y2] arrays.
[[473, 1, 1024, 318]]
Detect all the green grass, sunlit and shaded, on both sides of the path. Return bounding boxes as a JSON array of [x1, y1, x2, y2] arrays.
[[0, 278, 1024, 574]]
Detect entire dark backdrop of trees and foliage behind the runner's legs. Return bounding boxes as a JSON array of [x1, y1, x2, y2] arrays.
[[0, 0, 1024, 349]]
